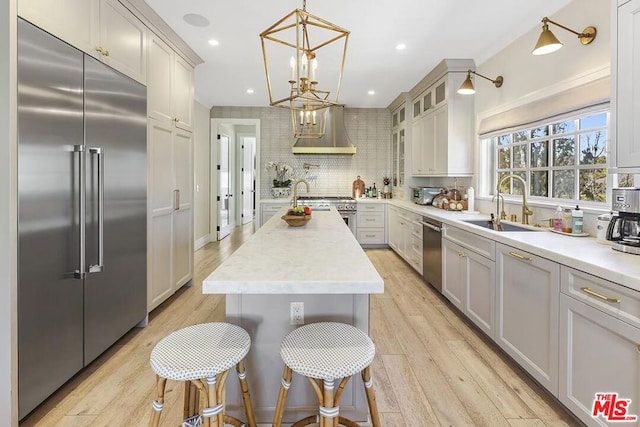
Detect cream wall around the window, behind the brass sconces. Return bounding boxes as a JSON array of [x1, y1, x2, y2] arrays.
[[473, 0, 611, 234]]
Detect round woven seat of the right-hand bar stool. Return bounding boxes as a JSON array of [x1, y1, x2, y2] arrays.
[[280, 322, 376, 380]]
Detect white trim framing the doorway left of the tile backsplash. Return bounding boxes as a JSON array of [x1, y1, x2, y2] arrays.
[[209, 118, 261, 241]]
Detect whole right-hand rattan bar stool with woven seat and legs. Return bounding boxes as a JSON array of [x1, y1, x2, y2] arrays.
[[273, 322, 380, 427]]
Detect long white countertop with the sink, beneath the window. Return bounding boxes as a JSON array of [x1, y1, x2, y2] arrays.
[[390, 200, 640, 291]]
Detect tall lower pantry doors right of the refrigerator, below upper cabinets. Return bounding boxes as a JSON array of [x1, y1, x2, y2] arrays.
[[148, 119, 193, 311]]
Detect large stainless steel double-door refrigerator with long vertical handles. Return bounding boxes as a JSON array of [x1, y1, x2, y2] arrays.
[[18, 20, 147, 419]]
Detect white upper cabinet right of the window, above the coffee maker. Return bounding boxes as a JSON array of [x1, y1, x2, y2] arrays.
[[611, 0, 640, 168]]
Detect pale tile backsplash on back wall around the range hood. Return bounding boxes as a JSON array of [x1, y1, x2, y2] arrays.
[[211, 107, 391, 199]]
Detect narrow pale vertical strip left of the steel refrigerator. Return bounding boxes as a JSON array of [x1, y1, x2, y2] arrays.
[[0, 0, 18, 425]]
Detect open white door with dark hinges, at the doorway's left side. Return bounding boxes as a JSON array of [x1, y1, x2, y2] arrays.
[[218, 134, 235, 240]]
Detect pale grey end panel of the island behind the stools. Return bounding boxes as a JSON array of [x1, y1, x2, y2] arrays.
[[226, 294, 375, 425]]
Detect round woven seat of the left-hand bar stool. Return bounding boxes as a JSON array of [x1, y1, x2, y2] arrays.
[[151, 323, 251, 381]]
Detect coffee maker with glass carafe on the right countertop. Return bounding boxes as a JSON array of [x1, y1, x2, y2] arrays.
[[607, 188, 640, 255]]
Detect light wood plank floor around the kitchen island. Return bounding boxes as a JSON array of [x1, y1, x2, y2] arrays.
[[21, 224, 579, 427]]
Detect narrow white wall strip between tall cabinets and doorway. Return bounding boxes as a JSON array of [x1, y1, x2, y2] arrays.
[[193, 102, 210, 249]]
